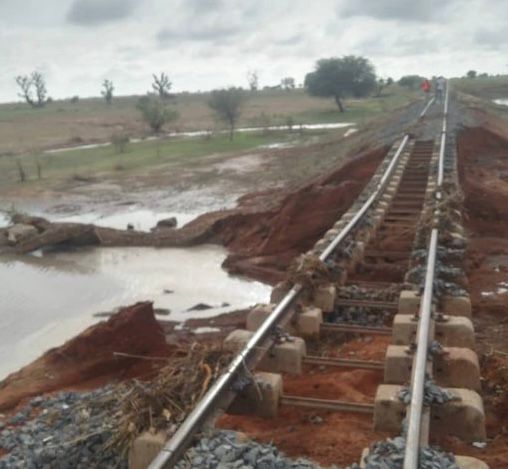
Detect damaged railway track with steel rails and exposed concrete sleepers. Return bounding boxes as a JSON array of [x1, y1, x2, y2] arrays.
[[144, 91, 485, 469]]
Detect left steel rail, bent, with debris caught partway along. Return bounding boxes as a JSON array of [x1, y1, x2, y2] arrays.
[[148, 96, 436, 469]]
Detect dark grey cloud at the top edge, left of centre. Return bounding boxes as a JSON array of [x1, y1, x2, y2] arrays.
[[67, 0, 138, 25]]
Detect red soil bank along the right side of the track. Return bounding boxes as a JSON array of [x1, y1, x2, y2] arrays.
[[439, 122, 508, 469]]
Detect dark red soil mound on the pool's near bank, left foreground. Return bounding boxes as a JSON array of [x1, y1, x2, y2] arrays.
[[0, 303, 171, 411]]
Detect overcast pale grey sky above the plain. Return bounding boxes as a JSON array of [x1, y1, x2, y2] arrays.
[[0, 0, 508, 101]]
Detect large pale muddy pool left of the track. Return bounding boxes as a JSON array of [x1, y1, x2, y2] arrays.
[[0, 245, 270, 379]]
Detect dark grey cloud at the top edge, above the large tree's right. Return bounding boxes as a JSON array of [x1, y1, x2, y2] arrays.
[[337, 0, 444, 22]]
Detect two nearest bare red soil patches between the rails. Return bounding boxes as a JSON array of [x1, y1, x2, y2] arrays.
[[218, 367, 387, 466]]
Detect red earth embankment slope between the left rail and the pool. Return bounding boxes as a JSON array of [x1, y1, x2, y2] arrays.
[[213, 148, 387, 283]]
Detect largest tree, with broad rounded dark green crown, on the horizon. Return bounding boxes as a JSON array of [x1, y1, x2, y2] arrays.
[[305, 55, 376, 112]]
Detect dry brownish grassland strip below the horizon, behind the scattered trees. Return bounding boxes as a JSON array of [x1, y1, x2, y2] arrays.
[[0, 85, 418, 156]]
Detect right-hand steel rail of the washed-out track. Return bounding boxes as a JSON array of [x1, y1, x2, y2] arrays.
[[403, 83, 449, 469]]
